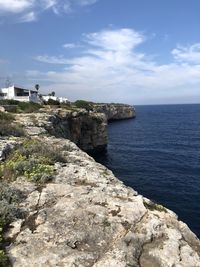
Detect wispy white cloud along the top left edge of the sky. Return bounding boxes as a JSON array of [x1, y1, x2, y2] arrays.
[[0, 0, 98, 22]]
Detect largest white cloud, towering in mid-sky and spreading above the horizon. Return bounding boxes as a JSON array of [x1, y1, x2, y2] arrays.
[[27, 29, 200, 103]]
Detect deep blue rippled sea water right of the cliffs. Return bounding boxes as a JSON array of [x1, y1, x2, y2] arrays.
[[96, 105, 200, 237]]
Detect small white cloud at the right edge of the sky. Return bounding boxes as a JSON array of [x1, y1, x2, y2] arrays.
[[172, 43, 200, 64]]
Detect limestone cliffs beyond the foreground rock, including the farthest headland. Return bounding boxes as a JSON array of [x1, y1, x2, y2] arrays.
[[15, 104, 135, 153]]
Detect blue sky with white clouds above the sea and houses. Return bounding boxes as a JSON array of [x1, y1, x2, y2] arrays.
[[0, 0, 200, 105]]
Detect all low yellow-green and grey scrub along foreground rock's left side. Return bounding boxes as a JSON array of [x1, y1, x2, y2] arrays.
[[0, 138, 65, 267]]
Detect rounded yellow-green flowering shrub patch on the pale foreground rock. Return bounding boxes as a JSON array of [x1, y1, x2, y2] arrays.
[[0, 140, 65, 183]]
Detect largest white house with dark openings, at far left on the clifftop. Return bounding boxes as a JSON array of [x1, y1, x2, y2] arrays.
[[0, 85, 41, 103]]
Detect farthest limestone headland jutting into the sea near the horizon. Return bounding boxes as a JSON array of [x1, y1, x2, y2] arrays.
[[94, 104, 136, 121]]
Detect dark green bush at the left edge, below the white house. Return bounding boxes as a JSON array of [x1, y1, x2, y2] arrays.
[[0, 112, 25, 136]]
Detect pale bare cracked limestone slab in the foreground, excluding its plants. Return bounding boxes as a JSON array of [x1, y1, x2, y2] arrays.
[[1, 136, 200, 267]]
